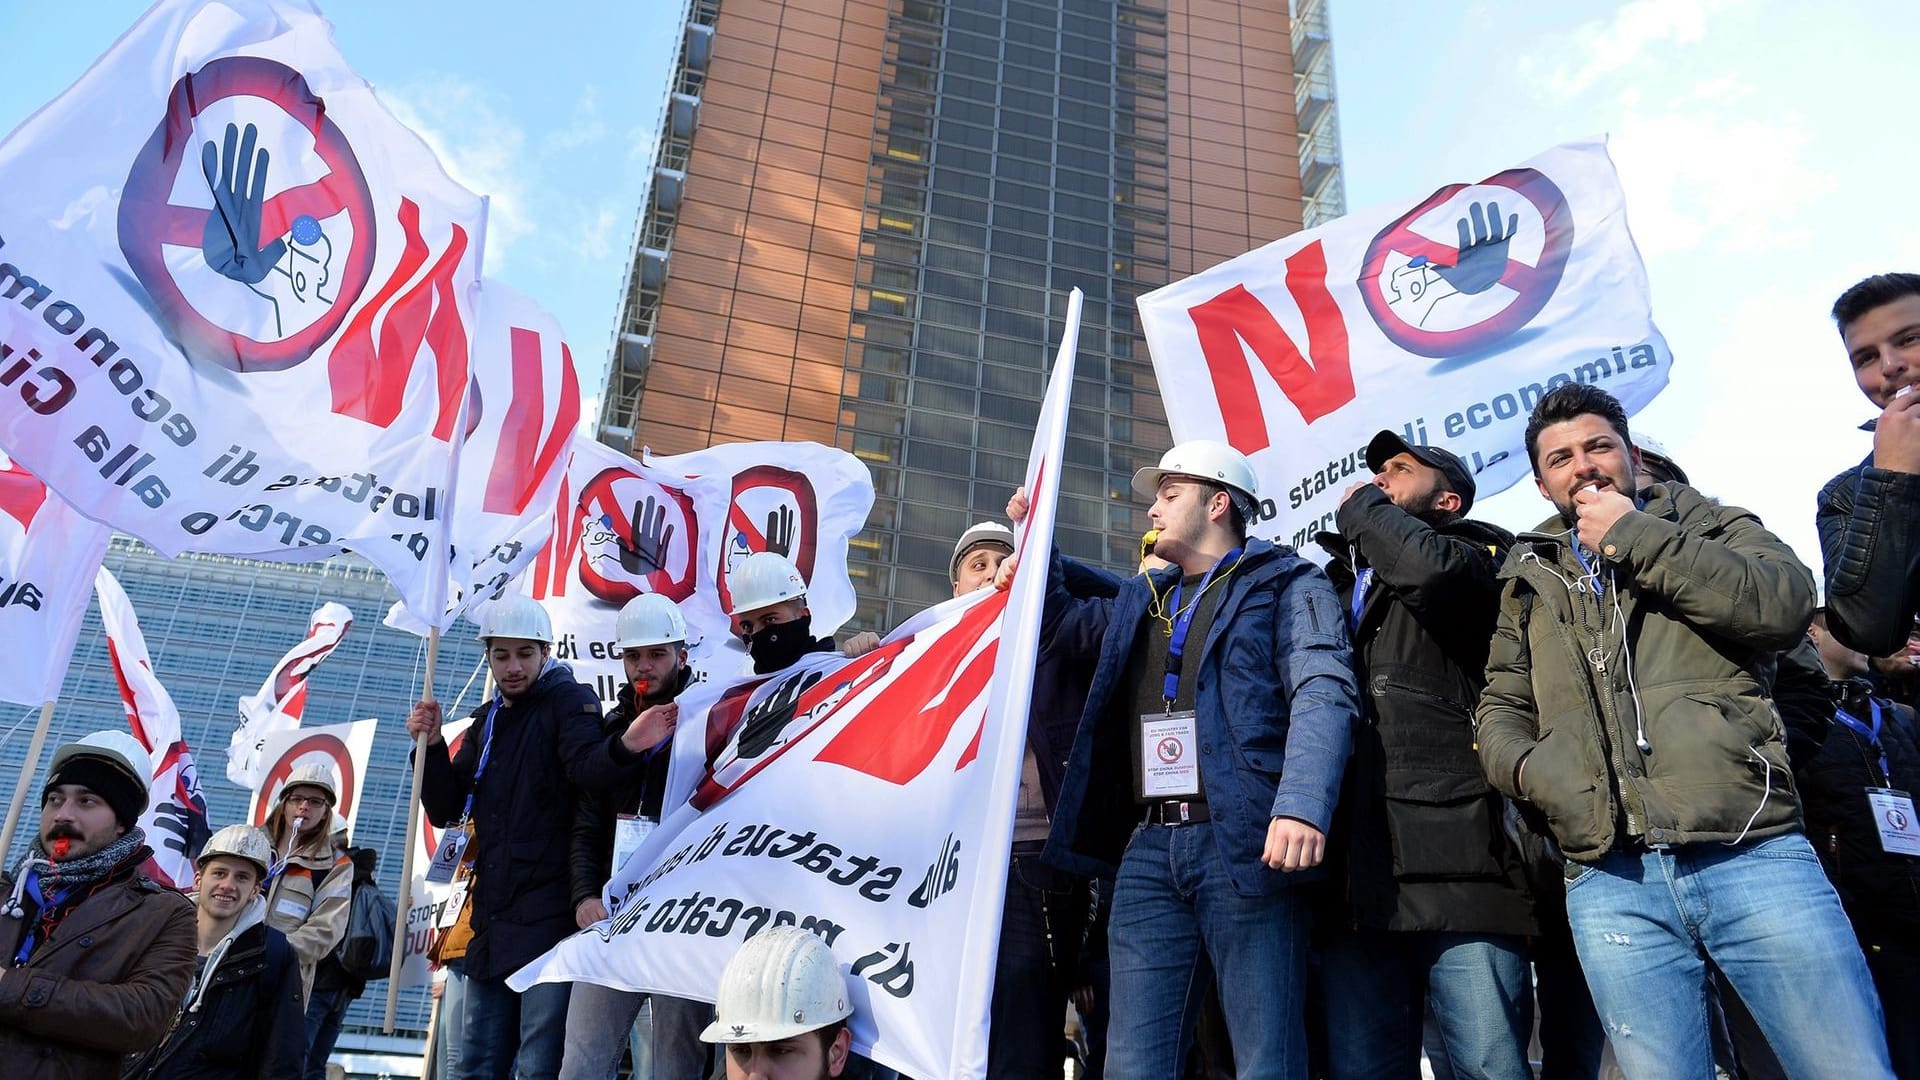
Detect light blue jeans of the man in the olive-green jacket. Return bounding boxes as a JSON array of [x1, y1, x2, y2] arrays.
[[1567, 832, 1893, 1080]]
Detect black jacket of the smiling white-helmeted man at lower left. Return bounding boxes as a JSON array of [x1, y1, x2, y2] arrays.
[[125, 922, 307, 1080]]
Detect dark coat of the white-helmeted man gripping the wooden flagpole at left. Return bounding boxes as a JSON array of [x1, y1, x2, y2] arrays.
[[420, 663, 632, 978]]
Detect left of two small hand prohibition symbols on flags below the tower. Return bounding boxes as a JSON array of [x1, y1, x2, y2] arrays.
[[580, 465, 701, 603]]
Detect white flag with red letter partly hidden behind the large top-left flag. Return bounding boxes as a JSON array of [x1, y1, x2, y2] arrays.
[[386, 279, 580, 634]]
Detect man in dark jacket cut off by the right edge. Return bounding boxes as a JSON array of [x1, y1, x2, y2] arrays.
[[1816, 273, 1920, 657]]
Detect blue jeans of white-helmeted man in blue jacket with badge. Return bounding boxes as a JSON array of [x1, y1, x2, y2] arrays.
[[1106, 822, 1309, 1080]]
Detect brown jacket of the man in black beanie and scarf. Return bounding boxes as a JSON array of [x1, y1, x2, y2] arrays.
[[0, 860, 196, 1080]]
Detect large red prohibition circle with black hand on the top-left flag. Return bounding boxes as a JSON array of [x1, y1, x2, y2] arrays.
[[119, 56, 378, 371]]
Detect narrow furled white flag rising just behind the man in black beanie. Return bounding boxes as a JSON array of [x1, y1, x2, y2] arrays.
[[94, 567, 211, 890]]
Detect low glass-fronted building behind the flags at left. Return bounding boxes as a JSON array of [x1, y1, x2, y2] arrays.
[[0, 536, 482, 1076]]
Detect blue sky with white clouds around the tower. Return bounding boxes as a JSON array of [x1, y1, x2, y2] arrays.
[[0, 0, 1920, 565]]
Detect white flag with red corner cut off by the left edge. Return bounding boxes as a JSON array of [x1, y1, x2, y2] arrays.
[[0, 454, 108, 705]]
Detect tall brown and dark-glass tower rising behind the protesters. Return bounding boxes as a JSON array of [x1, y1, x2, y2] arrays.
[[601, 0, 1331, 628]]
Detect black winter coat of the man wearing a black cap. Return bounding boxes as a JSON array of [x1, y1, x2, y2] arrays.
[[1319, 488, 1534, 934]]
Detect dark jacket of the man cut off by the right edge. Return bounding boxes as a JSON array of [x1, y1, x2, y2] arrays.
[[1814, 455, 1920, 655]]
